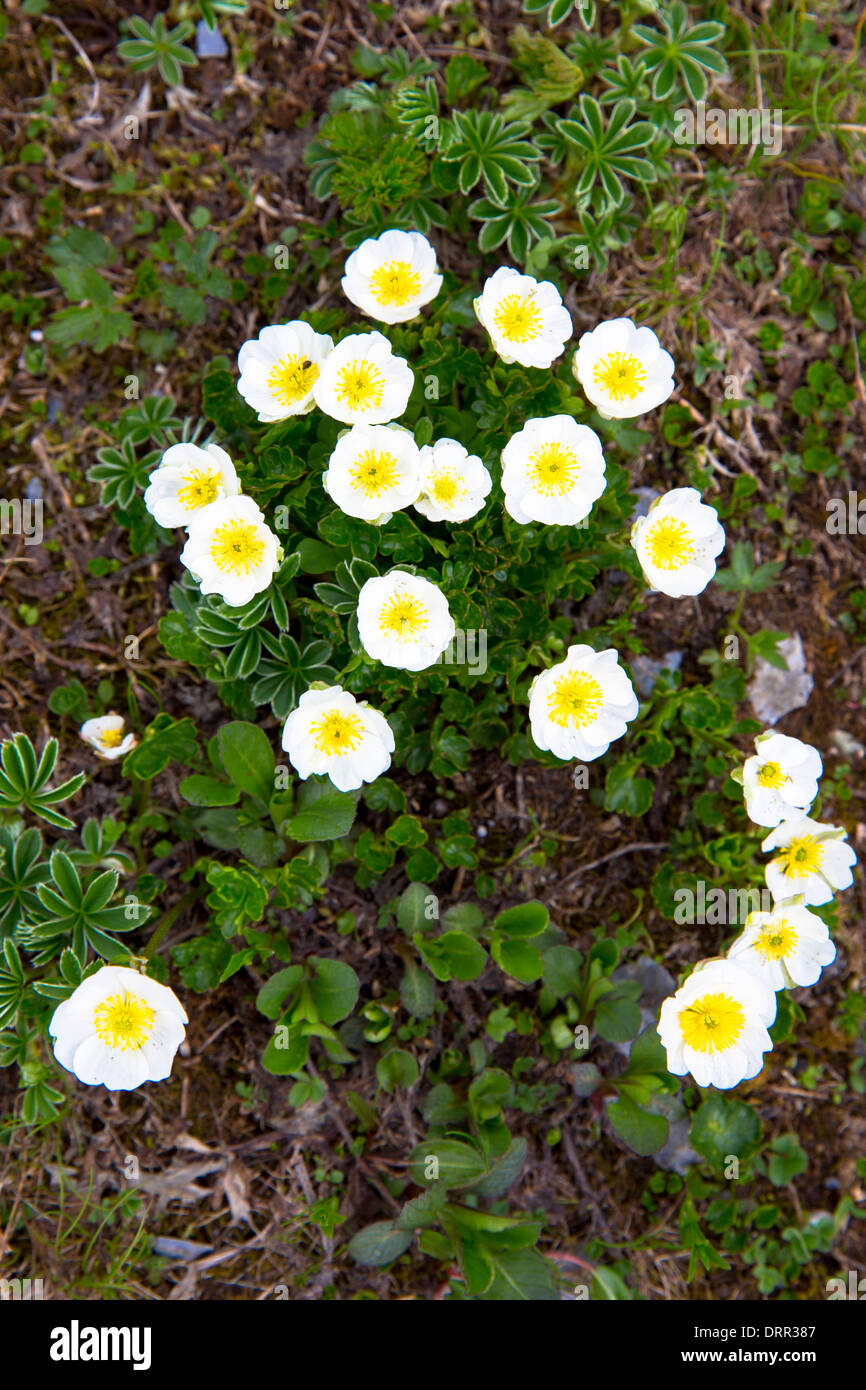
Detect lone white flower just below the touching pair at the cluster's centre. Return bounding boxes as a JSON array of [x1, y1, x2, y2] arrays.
[[357, 570, 456, 671]]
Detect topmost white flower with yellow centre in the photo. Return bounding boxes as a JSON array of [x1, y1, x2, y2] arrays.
[[341, 229, 442, 324]]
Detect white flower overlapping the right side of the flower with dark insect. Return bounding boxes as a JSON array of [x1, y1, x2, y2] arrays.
[[314, 332, 414, 425]]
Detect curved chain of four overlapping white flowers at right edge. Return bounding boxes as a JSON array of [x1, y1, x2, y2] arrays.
[[659, 730, 856, 1090]]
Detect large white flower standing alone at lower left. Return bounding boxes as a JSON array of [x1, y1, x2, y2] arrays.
[[49, 965, 188, 1091]]
